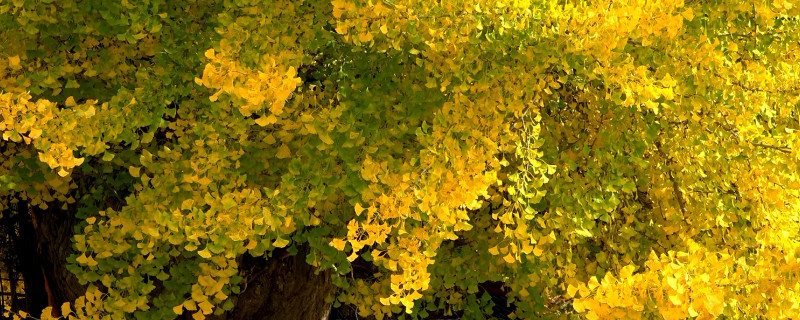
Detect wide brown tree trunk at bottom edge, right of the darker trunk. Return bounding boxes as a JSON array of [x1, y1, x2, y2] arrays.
[[219, 248, 334, 320]]
